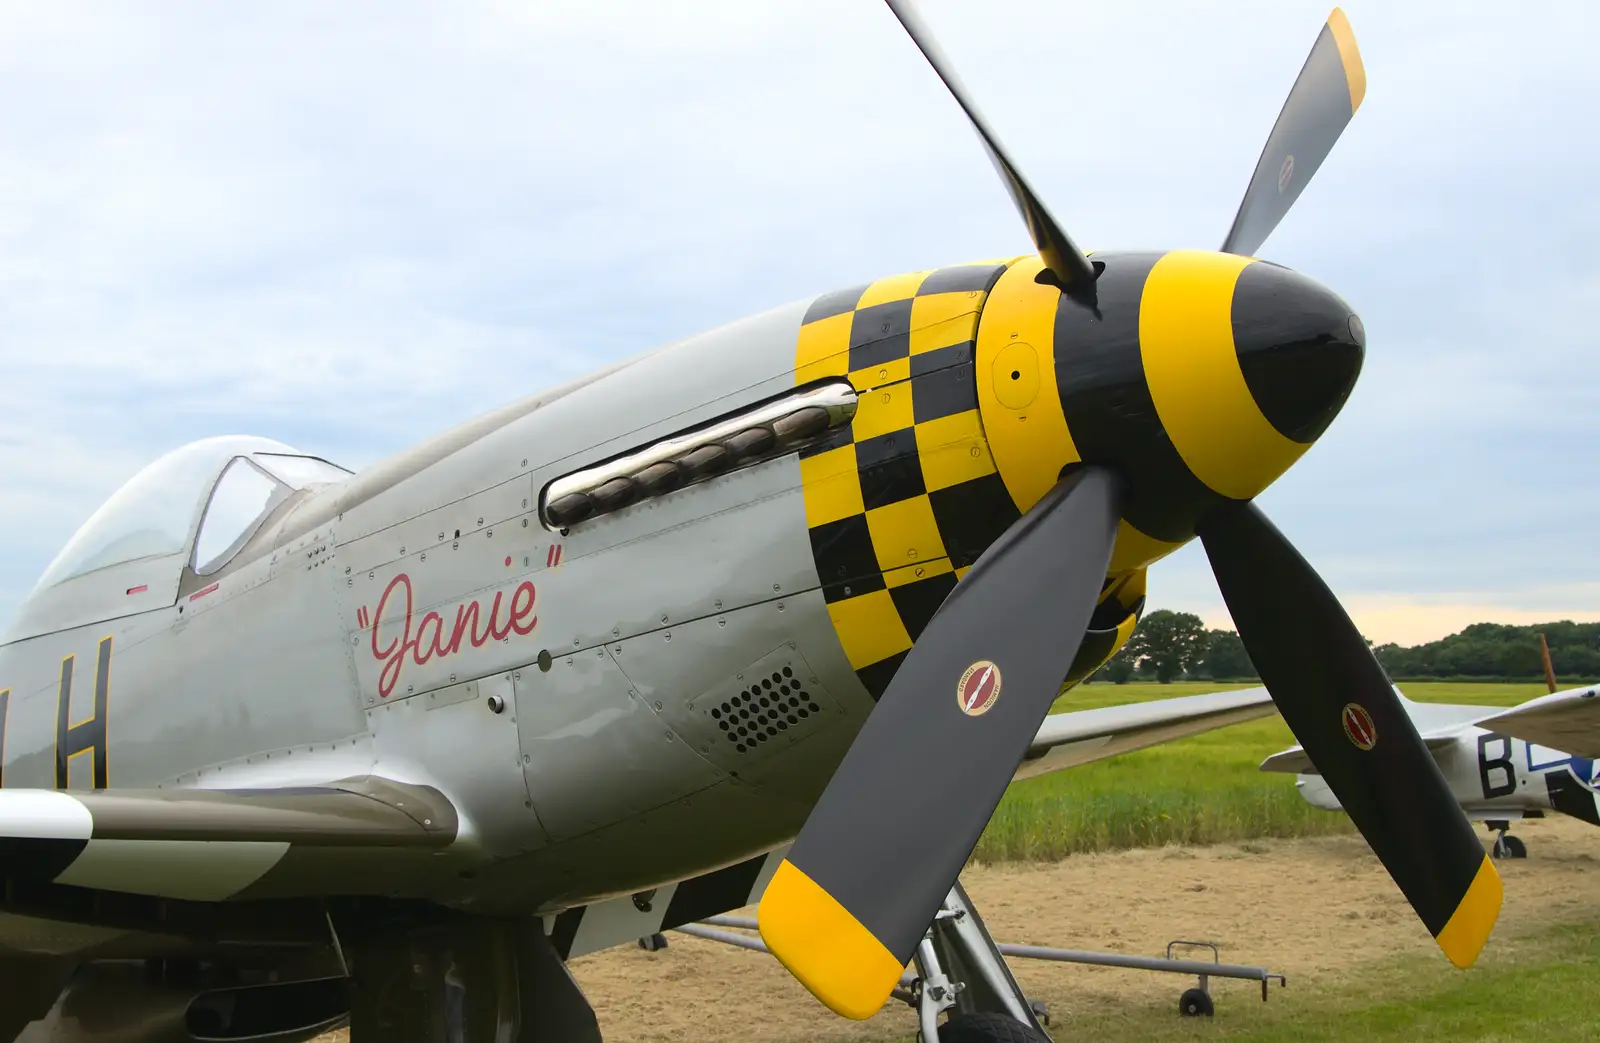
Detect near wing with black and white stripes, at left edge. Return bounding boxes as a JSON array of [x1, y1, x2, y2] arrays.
[[0, 776, 459, 901]]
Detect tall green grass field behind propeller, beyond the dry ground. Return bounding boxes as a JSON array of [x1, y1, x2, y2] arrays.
[[973, 683, 1544, 862]]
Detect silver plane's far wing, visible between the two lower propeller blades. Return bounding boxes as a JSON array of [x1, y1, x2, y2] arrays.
[[1013, 688, 1277, 779]]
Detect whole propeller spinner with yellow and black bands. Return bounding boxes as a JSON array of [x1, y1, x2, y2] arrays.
[[978, 251, 1365, 571]]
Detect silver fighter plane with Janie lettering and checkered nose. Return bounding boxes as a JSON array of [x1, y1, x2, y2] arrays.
[[0, 0, 1501, 1043]]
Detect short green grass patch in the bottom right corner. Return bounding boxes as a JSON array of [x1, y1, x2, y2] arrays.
[[889, 920, 1600, 1043]]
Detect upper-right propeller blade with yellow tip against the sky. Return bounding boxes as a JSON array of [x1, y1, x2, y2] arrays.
[[1222, 8, 1366, 258]]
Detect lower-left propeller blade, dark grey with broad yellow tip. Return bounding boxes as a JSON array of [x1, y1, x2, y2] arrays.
[[758, 467, 1118, 1021]]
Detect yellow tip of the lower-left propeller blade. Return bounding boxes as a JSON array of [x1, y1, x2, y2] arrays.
[[755, 859, 906, 1021]]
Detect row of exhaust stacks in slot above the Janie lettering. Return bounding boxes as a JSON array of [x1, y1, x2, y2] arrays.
[[539, 381, 856, 529]]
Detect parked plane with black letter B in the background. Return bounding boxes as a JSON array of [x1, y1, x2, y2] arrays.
[[1261, 671, 1600, 859]]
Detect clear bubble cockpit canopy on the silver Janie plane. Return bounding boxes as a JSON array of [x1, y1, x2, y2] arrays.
[[34, 435, 350, 598]]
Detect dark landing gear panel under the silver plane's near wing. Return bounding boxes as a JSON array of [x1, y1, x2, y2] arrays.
[[349, 917, 602, 1043]]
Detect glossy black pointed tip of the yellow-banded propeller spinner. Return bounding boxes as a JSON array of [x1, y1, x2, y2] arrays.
[[1232, 261, 1366, 443]]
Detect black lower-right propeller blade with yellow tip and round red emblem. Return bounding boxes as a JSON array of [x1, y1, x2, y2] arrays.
[[1200, 502, 1501, 968]]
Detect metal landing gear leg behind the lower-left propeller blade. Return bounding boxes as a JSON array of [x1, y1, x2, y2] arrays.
[[914, 883, 1050, 1043]]
